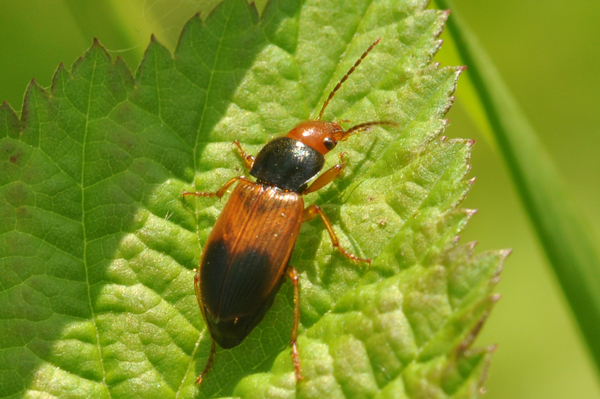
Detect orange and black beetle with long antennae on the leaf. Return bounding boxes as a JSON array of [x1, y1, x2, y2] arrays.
[[183, 38, 395, 384]]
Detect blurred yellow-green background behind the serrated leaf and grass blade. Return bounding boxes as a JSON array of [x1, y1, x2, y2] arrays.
[[0, 0, 600, 399]]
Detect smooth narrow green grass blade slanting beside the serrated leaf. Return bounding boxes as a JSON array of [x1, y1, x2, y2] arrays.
[[435, 0, 600, 376]]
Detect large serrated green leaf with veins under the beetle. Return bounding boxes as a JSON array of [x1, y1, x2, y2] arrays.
[[0, 0, 507, 398]]
